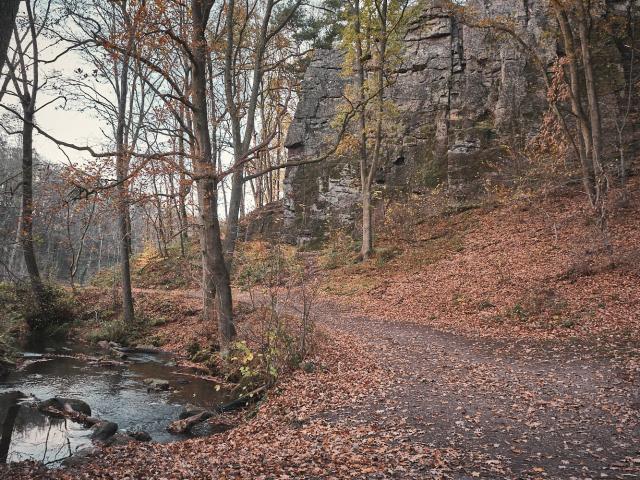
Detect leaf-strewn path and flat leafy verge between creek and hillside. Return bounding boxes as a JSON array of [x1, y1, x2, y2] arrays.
[[7, 291, 640, 479]]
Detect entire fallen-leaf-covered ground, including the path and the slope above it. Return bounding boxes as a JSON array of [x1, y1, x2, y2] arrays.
[[5, 186, 640, 480]]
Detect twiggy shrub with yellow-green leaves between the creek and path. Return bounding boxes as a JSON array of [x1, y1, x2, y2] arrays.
[[230, 242, 316, 393]]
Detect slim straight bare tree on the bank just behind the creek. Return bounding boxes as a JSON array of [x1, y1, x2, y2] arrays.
[[66, 0, 162, 323]]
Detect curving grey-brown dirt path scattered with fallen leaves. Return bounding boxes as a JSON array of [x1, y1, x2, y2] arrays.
[[318, 302, 640, 479]]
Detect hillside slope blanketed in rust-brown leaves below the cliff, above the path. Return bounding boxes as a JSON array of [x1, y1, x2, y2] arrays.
[[324, 182, 640, 350]]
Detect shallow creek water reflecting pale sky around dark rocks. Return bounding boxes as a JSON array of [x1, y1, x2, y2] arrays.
[[0, 347, 229, 465]]
